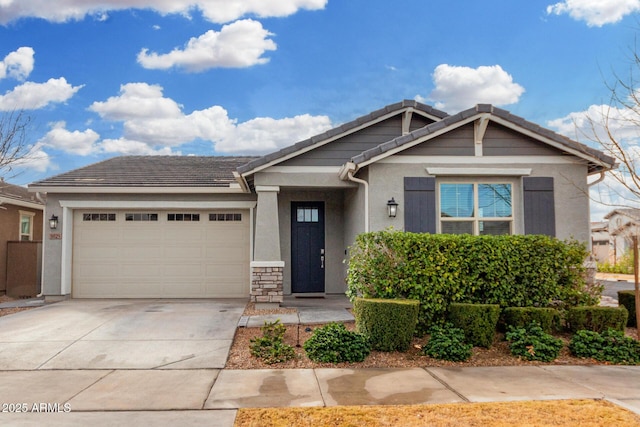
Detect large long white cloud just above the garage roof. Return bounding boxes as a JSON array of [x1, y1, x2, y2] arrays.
[[89, 83, 331, 154]]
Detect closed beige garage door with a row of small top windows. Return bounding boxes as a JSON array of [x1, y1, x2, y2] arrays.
[[72, 210, 250, 298]]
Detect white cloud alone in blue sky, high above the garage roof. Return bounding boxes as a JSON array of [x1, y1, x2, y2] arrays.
[[138, 19, 276, 72]]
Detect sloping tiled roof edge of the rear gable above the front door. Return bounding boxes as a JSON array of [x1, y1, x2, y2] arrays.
[[238, 100, 448, 175]]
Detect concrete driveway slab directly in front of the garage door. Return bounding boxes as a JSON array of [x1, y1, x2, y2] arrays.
[[0, 299, 247, 371]]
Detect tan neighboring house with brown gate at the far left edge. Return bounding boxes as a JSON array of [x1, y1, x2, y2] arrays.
[[0, 178, 44, 295]]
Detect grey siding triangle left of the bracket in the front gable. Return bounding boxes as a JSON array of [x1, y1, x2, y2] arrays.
[[396, 123, 475, 156]]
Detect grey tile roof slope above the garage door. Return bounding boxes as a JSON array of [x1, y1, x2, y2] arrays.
[[30, 156, 257, 187]]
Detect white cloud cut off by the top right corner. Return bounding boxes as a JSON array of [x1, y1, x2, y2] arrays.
[[547, 0, 640, 27]]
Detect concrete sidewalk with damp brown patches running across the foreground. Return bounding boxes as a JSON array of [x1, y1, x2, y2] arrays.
[[0, 365, 640, 427]]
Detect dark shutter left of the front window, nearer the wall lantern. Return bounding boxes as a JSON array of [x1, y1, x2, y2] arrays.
[[404, 177, 436, 233]]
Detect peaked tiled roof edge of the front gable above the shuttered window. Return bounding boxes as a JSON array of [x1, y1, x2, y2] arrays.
[[351, 104, 615, 172]]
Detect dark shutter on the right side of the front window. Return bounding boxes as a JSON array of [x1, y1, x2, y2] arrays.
[[522, 177, 556, 237]]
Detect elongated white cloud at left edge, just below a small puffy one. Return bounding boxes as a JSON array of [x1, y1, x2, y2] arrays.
[[0, 77, 83, 111]]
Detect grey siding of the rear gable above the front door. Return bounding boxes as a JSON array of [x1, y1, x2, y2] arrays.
[[280, 115, 415, 166]]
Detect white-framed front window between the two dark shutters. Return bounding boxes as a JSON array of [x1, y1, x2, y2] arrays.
[[440, 183, 513, 235]]
